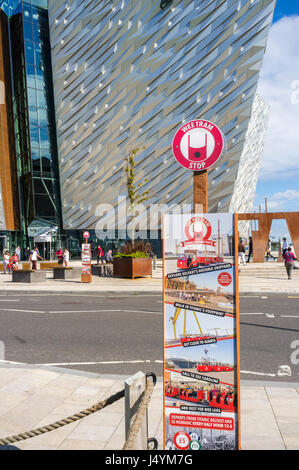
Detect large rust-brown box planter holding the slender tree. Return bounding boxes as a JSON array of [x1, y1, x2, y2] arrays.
[[113, 258, 153, 279]]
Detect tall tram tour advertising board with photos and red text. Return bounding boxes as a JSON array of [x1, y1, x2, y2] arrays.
[[163, 214, 239, 450]]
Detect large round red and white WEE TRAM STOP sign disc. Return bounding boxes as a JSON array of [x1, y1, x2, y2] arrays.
[[172, 119, 224, 171]]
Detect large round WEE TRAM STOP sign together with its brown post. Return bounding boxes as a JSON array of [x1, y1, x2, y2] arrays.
[[172, 119, 225, 214]]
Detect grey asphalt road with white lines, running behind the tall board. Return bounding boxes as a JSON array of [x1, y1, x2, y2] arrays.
[[0, 295, 299, 382]]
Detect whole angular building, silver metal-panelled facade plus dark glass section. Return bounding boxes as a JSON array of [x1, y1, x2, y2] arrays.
[[0, 0, 275, 254]]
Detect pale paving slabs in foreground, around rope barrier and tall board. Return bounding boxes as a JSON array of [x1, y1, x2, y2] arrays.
[[0, 362, 299, 450]]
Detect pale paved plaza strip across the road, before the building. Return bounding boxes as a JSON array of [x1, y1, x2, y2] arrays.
[[0, 260, 299, 295]]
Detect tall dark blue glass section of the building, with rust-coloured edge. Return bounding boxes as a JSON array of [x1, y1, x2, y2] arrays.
[[0, 0, 62, 256]]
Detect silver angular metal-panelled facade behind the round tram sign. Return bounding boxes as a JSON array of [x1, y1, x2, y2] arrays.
[[49, 0, 275, 242]]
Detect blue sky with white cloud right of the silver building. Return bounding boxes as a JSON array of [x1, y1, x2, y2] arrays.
[[254, 0, 299, 229]]
